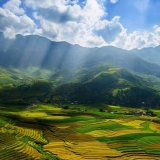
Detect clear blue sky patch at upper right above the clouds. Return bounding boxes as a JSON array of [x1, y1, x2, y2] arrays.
[[106, 0, 160, 32]]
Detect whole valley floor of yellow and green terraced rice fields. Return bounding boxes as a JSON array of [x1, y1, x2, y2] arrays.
[[0, 104, 160, 160]]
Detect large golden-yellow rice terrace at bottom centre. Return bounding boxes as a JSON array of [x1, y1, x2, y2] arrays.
[[44, 129, 120, 160]]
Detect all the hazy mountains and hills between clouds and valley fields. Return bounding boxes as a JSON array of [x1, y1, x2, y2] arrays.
[[0, 33, 160, 107]]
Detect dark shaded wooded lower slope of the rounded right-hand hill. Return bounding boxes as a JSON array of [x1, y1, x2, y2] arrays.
[[52, 83, 160, 108]]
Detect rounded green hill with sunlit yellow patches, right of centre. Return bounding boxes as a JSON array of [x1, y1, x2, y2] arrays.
[[51, 66, 160, 107]]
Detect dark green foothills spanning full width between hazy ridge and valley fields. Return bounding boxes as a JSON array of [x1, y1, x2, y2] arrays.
[[0, 65, 160, 108]]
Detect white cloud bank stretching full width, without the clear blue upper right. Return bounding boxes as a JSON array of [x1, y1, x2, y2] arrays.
[[0, 0, 160, 49]]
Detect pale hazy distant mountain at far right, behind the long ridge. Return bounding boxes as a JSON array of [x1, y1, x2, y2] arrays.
[[130, 46, 160, 65]]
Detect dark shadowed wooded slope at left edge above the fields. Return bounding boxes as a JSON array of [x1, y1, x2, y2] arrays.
[[0, 82, 52, 105]]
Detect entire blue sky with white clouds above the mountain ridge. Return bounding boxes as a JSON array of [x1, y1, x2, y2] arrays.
[[0, 0, 160, 50]]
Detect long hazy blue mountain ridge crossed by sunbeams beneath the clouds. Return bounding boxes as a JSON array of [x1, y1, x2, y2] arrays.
[[0, 34, 160, 77]]
